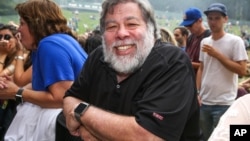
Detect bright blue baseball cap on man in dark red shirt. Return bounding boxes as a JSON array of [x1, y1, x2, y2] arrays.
[[180, 7, 202, 26]]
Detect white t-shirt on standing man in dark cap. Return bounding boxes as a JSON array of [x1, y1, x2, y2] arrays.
[[199, 33, 248, 105]]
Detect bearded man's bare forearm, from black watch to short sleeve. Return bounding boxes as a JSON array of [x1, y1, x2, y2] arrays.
[[81, 106, 162, 141]]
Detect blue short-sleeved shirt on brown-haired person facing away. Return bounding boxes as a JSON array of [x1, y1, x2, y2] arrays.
[[32, 34, 87, 91]]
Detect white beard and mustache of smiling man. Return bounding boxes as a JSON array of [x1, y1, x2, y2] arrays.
[[103, 24, 154, 74]]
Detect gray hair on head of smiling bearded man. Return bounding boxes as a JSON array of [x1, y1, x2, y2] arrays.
[[100, 0, 160, 39]]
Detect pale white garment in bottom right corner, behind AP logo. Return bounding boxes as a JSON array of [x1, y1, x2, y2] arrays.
[[208, 94, 250, 141]]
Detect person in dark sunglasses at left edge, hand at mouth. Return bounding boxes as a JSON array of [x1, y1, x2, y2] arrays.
[[0, 24, 18, 140]]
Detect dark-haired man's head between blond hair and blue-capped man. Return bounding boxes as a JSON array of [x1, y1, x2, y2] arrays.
[[173, 26, 189, 51]]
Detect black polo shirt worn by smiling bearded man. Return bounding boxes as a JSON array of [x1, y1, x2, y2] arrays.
[[66, 43, 199, 141]]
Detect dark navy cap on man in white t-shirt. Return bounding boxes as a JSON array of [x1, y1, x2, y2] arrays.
[[204, 3, 227, 16]]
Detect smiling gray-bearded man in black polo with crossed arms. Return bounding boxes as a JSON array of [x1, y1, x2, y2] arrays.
[[63, 0, 199, 141]]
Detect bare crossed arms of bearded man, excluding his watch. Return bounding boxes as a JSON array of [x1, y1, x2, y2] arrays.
[[63, 97, 163, 141]]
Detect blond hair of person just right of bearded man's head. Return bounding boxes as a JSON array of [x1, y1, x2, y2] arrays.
[[160, 28, 177, 46]]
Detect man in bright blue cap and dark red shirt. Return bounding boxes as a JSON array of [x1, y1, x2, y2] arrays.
[[180, 7, 210, 73]]
